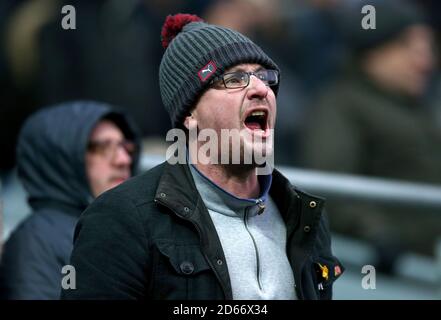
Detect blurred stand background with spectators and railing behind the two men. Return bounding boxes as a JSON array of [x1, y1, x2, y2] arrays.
[[0, 0, 441, 299]]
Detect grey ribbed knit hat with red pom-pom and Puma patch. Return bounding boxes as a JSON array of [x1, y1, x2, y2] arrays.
[[159, 14, 279, 127]]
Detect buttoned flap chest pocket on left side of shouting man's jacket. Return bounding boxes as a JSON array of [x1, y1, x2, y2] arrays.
[[154, 241, 219, 299]]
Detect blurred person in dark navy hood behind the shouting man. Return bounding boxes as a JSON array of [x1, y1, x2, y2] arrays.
[[0, 101, 139, 299]]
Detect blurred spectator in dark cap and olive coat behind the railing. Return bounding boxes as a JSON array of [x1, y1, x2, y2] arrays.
[[304, 0, 441, 270]]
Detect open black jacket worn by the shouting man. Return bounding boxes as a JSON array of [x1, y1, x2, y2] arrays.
[[62, 163, 343, 300]]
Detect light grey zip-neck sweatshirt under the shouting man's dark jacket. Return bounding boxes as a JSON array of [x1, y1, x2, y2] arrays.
[[190, 165, 296, 300]]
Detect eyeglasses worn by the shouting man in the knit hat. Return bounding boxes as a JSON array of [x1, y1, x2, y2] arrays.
[[211, 69, 279, 89]]
